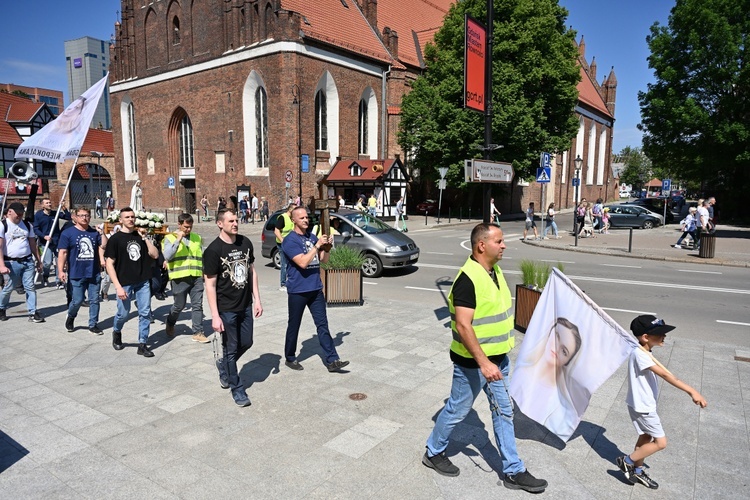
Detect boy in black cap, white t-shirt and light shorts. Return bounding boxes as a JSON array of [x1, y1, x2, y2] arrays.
[[617, 314, 708, 490]]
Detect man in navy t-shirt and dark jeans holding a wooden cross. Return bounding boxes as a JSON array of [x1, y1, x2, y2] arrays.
[[281, 208, 349, 372]]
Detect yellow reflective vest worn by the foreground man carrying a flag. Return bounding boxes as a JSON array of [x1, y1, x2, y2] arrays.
[[448, 257, 516, 358]]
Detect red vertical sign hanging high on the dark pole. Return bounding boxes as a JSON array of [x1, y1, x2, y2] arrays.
[[464, 15, 487, 113]]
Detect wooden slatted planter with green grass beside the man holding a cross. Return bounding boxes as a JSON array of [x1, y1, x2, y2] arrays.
[[320, 245, 365, 306]]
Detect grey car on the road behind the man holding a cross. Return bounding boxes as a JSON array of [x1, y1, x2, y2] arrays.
[[261, 209, 419, 278]]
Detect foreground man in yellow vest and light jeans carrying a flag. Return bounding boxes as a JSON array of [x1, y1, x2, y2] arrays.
[[422, 223, 547, 493]]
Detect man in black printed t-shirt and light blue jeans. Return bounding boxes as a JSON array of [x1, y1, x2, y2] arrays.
[[104, 207, 159, 358]]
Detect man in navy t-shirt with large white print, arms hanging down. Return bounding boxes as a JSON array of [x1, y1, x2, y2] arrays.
[[57, 207, 104, 335]]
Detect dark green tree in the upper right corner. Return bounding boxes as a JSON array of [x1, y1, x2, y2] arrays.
[[638, 0, 750, 213]]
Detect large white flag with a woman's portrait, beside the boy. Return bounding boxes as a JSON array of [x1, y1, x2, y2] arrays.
[[510, 269, 638, 441]]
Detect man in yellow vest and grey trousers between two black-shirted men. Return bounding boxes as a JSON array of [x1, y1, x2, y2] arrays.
[[162, 214, 209, 344]]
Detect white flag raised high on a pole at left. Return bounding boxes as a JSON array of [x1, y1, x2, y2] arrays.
[[16, 73, 109, 163]]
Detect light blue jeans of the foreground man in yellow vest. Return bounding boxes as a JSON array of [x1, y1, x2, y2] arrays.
[[427, 356, 526, 475]]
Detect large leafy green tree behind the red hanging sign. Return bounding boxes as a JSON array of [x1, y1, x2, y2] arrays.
[[399, 0, 580, 190]]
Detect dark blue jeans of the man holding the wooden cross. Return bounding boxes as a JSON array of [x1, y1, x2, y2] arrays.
[[284, 290, 339, 365]]
